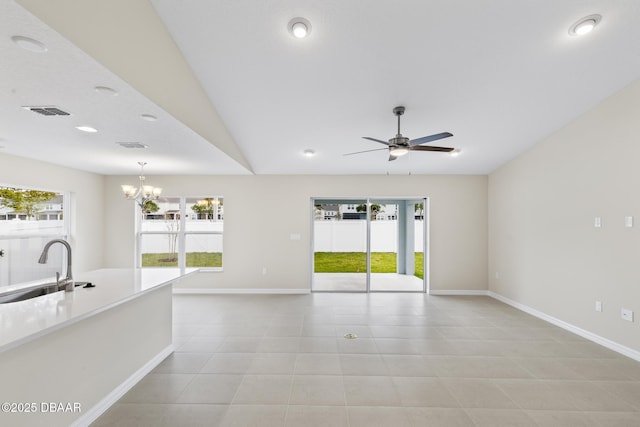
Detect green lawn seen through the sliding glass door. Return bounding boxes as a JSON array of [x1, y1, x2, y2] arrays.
[[314, 252, 424, 279]]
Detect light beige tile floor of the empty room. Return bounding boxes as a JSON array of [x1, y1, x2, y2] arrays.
[[93, 294, 640, 427]]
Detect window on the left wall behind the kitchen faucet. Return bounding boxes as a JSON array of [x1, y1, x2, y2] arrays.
[[0, 185, 69, 287]]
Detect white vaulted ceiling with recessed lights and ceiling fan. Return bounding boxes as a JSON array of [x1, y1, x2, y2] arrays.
[[0, 0, 640, 174]]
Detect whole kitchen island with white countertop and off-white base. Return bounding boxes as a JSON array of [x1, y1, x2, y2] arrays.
[[0, 268, 196, 426]]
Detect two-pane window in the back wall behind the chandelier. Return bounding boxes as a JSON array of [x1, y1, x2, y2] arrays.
[[138, 196, 224, 270]]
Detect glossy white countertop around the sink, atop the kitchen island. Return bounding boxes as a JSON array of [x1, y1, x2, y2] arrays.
[[0, 268, 197, 352]]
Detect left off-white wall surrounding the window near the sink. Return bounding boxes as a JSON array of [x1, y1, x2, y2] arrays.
[[0, 154, 105, 272]]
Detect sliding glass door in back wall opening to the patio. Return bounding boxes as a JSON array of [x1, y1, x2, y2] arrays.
[[311, 198, 428, 292]]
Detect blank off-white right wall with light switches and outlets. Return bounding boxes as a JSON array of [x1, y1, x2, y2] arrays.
[[489, 81, 640, 351]]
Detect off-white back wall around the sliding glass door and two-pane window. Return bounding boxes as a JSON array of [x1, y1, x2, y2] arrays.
[[105, 175, 487, 290]]
